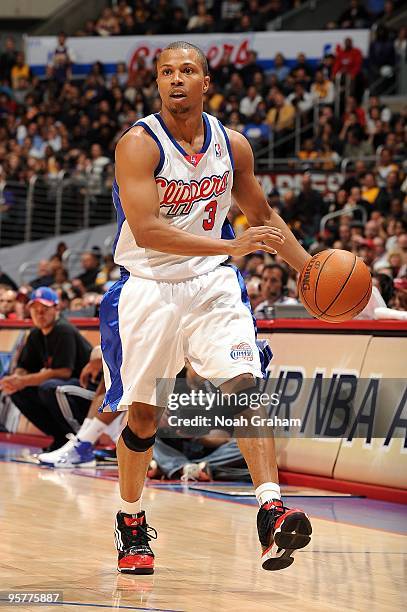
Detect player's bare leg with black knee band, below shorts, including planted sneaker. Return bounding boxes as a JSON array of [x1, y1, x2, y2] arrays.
[[115, 402, 163, 574]]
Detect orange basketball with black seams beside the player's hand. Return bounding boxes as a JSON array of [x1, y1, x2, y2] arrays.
[[298, 249, 372, 323]]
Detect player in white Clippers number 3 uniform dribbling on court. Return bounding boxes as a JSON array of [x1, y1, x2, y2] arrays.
[[100, 42, 311, 574]]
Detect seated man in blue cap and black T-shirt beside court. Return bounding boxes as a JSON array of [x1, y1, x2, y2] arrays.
[[0, 287, 92, 450]]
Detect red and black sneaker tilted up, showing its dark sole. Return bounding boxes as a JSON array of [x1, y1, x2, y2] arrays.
[[257, 499, 312, 570]]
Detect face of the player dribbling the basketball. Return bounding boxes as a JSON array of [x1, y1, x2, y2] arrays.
[[157, 49, 210, 115]]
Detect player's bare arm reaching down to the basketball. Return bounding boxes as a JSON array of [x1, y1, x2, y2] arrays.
[[228, 130, 311, 272]]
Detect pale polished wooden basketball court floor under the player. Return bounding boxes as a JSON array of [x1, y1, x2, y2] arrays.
[[0, 443, 407, 612]]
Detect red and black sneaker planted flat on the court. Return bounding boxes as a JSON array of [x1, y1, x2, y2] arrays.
[[114, 511, 157, 574]]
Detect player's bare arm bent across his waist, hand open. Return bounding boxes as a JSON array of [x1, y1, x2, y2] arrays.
[[116, 127, 284, 256]]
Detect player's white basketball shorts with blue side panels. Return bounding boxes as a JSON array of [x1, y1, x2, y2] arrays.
[[100, 264, 264, 411]]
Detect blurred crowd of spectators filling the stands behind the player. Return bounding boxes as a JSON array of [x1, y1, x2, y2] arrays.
[[0, 0, 407, 316]]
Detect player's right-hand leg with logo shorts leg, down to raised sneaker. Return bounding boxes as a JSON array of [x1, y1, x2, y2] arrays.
[[186, 266, 311, 569]]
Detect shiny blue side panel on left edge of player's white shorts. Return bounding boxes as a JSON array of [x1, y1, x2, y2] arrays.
[[99, 268, 130, 412]]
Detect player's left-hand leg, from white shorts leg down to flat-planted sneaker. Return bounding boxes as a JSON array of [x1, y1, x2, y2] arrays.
[[100, 275, 184, 573]]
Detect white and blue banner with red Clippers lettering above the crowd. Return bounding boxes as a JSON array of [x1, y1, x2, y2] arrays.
[[25, 30, 369, 76]]
